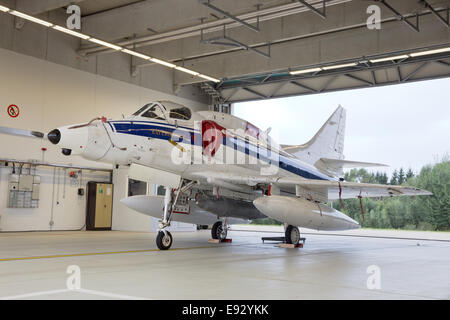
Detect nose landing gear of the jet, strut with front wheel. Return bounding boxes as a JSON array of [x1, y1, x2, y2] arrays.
[[156, 179, 195, 250]]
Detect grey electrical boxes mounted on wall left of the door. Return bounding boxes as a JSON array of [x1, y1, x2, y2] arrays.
[[8, 174, 41, 208]]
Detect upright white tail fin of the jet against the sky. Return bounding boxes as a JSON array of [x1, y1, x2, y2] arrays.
[[281, 106, 346, 165]]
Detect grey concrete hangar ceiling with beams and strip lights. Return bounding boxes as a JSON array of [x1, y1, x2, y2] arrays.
[[0, 0, 450, 103]]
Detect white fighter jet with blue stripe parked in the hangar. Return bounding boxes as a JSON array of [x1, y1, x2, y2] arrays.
[[0, 101, 431, 250]]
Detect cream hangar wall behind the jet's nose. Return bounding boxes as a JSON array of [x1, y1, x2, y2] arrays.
[[0, 49, 207, 231]]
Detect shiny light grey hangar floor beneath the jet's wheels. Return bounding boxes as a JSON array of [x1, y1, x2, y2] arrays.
[[0, 228, 450, 300]]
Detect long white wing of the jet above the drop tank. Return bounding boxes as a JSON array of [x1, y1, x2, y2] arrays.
[[188, 172, 432, 200]]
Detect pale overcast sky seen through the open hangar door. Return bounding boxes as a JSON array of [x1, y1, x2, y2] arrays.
[[233, 78, 450, 175]]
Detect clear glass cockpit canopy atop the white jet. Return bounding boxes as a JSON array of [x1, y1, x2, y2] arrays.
[[133, 101, 192, 121]]
